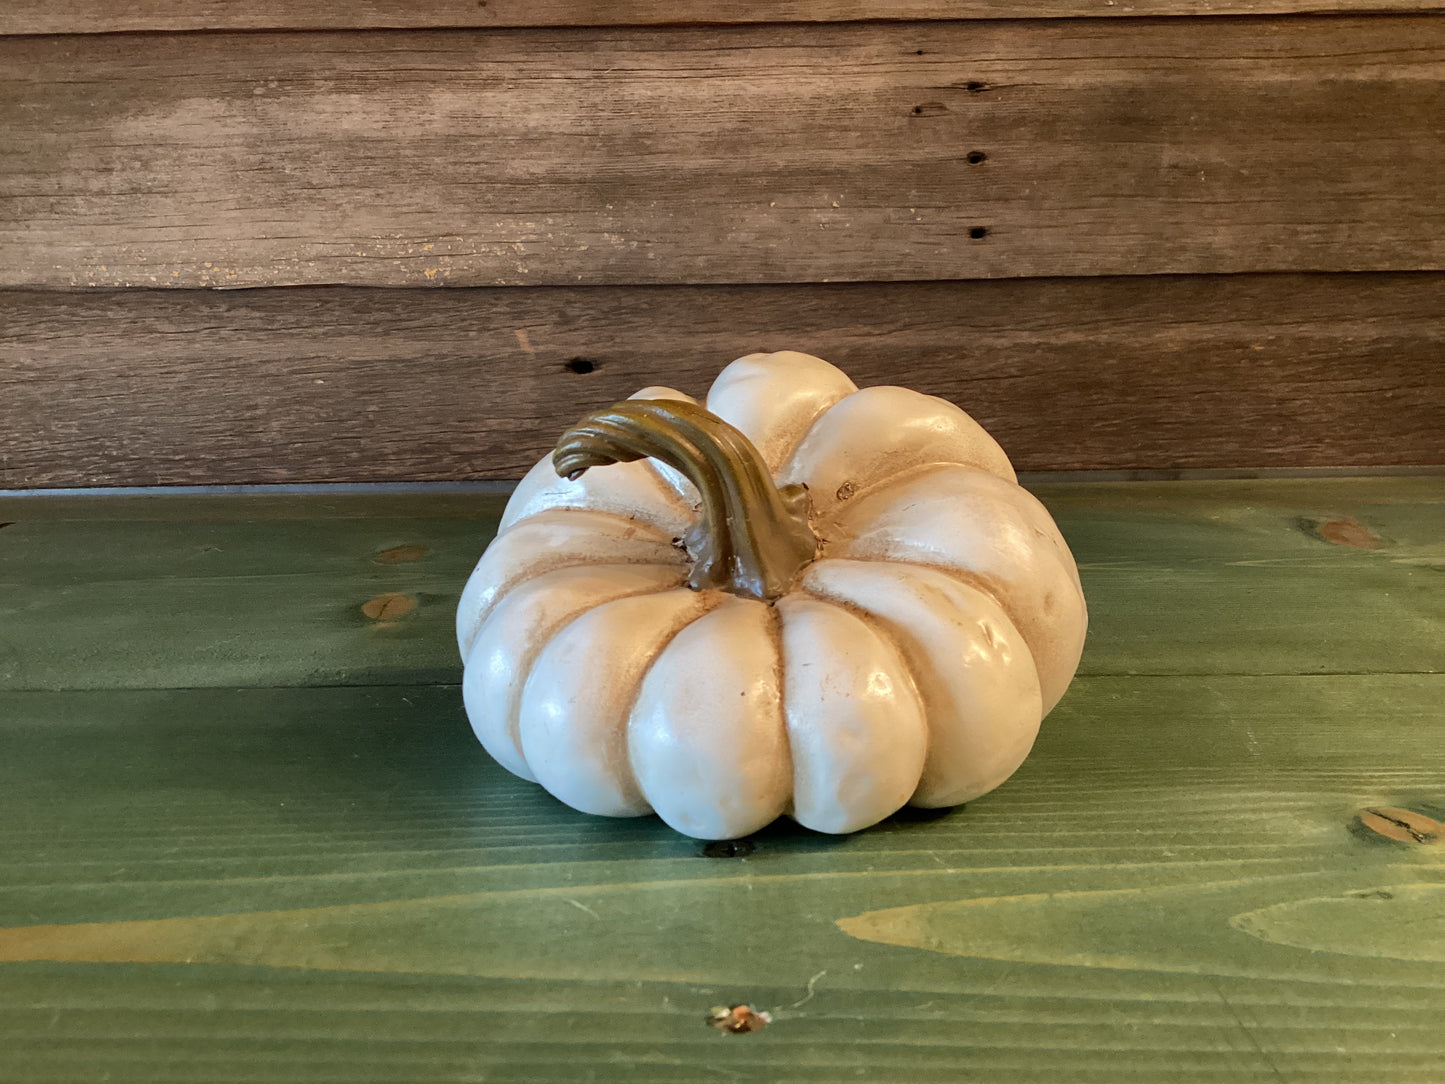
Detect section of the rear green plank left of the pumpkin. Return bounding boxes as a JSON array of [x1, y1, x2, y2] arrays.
[[0, 513, 496, 688]]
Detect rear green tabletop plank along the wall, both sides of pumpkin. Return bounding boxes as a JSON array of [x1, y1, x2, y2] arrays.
[[0, 477, 1445, 689]]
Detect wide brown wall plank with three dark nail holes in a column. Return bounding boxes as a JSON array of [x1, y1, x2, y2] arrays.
[[0, 16, 1445, 286]]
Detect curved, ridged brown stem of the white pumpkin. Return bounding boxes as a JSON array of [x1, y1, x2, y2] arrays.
[[552, 399, 818, 601]]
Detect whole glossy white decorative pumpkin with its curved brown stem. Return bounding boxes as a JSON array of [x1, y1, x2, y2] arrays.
[[457, 351, 1087, 840]]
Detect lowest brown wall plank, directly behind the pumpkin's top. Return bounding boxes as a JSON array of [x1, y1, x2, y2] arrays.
[[0, 273, 1445, 489]]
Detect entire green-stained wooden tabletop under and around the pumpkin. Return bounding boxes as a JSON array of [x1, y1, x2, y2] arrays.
[[0, 476, 1445, 1084]]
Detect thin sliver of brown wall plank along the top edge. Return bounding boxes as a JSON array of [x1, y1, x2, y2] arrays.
[[0, 0, 1445, 33]]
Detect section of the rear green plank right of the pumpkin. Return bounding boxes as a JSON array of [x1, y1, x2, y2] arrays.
[[1039, 477, 1445, 674]]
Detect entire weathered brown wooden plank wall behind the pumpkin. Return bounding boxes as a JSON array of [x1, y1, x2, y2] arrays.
[[0, 0, 1445, 489]]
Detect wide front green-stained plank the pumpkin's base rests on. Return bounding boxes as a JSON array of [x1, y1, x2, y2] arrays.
[[0, 675, 1445, 1084]]
